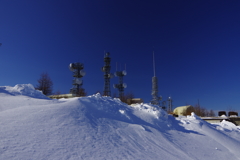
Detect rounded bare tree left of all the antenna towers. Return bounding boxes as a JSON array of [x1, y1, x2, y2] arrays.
[[36, 73, 53, 95]]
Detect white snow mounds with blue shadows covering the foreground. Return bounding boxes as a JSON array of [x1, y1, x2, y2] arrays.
[[0, 84, 240, 160]]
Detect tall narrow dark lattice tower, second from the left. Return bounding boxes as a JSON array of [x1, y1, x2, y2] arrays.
[[102, 52, 114, 96]]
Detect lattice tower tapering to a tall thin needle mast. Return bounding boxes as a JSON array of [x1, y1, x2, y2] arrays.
[[151, 51, 162, 106]]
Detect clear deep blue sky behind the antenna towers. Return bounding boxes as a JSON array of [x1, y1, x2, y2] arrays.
[[0, 0, 240, 110]]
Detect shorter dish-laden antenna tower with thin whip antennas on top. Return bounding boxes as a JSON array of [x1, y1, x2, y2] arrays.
[[113, 65, 127, 98]]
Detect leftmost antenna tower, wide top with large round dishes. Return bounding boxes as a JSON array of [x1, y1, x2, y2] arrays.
[[69, 62, 86, 96]]
